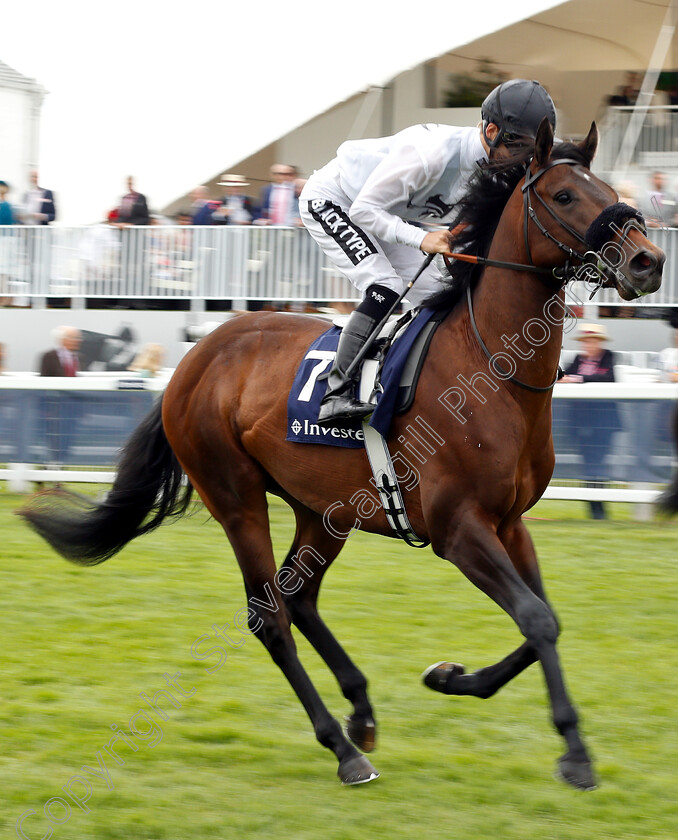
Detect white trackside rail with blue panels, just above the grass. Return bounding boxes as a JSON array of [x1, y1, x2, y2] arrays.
[[0, 380, 678, 520]]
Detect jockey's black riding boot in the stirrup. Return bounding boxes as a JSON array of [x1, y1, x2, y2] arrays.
[[318, 285, 398, 423]]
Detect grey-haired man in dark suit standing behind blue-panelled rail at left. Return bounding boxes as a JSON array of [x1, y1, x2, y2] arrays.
[[40, 327, 82, 466]]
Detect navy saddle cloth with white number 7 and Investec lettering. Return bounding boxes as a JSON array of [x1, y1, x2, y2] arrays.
[[286, 309, 447, 449]]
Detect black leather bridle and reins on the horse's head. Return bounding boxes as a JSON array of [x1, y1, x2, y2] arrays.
[[444, 158, 647, 393]]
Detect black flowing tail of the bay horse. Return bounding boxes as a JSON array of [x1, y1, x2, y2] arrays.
[[17, 400, 193, 566]]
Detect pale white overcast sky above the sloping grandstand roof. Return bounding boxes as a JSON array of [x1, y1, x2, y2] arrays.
[[0, 0, 556, 224]]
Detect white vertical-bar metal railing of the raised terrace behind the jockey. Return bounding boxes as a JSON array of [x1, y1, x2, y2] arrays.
[[0, 225, 678, 307]]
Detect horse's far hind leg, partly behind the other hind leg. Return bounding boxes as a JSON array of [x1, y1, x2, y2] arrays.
[[284, 508, 376, 752]]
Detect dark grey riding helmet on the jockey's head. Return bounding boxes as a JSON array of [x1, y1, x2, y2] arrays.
[[480, 79, 556, 148]]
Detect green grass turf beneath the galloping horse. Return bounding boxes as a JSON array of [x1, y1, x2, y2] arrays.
[[0, 491, 678, 840]]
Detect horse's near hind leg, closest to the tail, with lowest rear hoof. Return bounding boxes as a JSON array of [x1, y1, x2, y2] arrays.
[[189, 462, 379, 784]]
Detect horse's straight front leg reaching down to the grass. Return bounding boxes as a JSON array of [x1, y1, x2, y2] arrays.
[[430, 514, 595, 789]]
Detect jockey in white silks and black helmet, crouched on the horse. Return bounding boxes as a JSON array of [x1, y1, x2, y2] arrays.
[[299, 79, 556, 423]]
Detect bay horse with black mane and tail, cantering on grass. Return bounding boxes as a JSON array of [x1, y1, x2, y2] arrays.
[[19, 120, 665, 789]]
